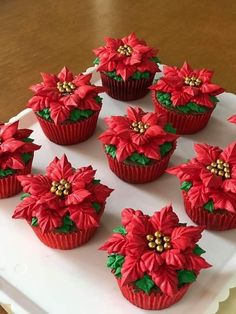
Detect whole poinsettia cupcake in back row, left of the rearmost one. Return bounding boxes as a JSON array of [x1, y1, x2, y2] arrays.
[[27, 67, 104, 145]]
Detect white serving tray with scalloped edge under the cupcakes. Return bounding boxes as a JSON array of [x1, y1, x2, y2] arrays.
[[0, 68, 236, 314]]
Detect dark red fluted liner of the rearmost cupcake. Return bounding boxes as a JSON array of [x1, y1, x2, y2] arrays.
[[100, 72, 154, 101]]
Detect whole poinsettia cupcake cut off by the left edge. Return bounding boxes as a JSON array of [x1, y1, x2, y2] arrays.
[[0, 121, 41, 198]]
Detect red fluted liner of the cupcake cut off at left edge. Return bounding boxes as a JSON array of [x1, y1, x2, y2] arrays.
[[0, 157, 33, 199]]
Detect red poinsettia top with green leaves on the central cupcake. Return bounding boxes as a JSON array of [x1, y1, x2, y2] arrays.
[[99, 107, 177, 165]]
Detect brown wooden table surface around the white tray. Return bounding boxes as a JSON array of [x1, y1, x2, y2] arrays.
[[0, 0, 236, 314]]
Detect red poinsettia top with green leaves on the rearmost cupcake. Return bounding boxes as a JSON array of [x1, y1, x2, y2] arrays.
[[93, 33, 159, 81]]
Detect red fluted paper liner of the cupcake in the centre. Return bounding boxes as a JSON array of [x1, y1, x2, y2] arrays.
[[106, 143, 176, 184]]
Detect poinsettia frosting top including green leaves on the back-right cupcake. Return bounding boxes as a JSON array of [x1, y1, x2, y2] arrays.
[[150, 62, 224, 113]]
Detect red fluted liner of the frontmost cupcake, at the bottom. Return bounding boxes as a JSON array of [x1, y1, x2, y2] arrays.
[[117, 279, 190, 310]]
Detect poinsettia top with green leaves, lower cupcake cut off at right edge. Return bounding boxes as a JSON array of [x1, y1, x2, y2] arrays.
[[166, 142, 236, 213]]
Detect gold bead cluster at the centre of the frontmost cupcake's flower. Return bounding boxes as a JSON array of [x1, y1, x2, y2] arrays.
[[146, 231, 171, 253]]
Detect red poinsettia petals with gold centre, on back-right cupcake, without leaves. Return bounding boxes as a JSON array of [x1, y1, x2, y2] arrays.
[[150, 62, 224, 108]]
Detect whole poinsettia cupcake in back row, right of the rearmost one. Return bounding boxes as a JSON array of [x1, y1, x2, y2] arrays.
[[150, 62, 224, 134]]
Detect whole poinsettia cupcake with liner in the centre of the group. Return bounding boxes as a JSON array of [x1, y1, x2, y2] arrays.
[[99, 107, 177, 183]]
